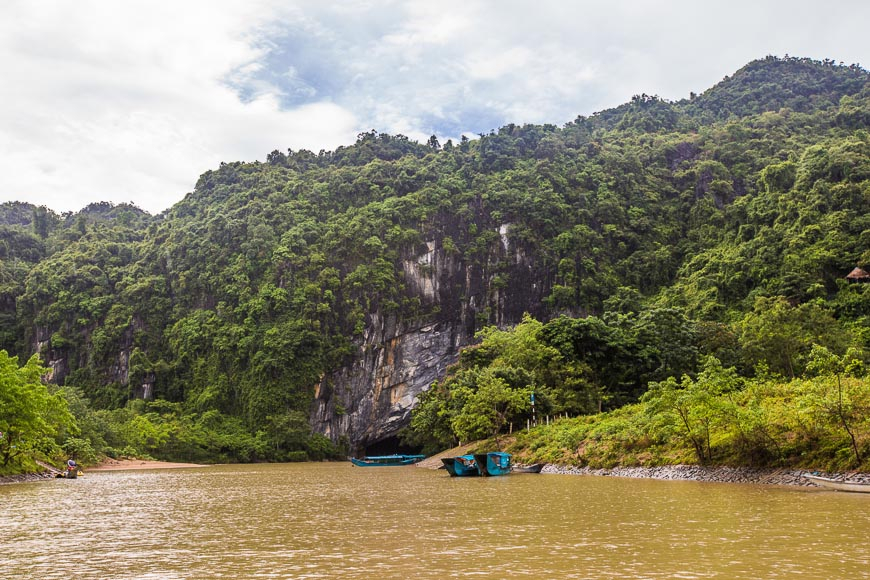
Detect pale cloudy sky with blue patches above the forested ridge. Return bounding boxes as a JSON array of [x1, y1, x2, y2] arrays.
[[0, 0, 870, 214]]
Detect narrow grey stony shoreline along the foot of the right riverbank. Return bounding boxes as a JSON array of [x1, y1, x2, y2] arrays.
[[541, 464, 870, 487]]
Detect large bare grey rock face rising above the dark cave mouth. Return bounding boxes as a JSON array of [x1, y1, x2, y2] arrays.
[[311, 225, 551, 452]]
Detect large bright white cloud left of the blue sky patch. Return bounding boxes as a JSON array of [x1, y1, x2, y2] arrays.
[[0, 2, 357, 212]]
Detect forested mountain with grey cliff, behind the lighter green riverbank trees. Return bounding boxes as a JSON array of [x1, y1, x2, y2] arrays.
[[0, 57, 870, 462]]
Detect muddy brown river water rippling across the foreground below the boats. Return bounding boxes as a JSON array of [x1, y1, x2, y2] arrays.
[[0, 463, 870, 580]]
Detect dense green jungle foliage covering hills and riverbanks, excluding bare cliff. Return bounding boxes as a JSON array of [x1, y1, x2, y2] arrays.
[[0, 57, 870, 472]]
